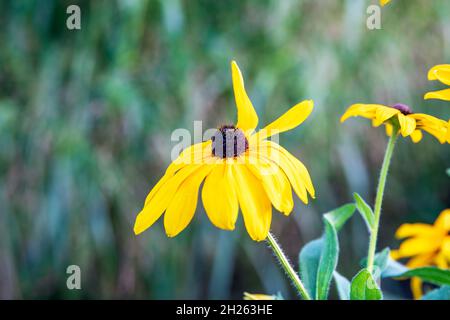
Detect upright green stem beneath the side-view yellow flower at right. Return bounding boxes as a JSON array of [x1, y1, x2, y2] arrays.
[[367, 131, 398, 273]]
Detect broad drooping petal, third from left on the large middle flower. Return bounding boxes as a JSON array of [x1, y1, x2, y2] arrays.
[[202, 164, 239, 230]]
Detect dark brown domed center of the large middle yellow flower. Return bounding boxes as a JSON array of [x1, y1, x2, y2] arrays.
[[211, 125, 248, 158]]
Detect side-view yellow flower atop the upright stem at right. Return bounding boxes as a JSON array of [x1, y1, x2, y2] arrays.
[[341, 103, 450, 143]]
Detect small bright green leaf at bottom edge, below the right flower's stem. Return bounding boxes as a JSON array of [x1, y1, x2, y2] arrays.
[[350, 269, 383, 300]]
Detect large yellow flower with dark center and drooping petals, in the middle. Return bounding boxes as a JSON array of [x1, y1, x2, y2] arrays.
[[134, 61, 315, 241]]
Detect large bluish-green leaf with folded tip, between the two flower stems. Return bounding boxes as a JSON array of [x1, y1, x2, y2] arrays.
[[299, 204, 355, 300]]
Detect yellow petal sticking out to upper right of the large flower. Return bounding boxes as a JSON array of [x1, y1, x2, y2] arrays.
[[255, 100, 314, 139]]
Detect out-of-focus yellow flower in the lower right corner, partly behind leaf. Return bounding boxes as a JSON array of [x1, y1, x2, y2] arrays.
[[391, 209, 450, 299]]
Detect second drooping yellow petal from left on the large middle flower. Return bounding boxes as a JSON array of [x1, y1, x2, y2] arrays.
[[164, 165, 212, 237]]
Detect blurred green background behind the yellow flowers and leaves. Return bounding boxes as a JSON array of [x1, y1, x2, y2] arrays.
[[0, 0, 450, 299]]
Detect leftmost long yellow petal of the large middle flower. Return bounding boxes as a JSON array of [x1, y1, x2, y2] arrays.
[[134, 165, 200, 234]]
